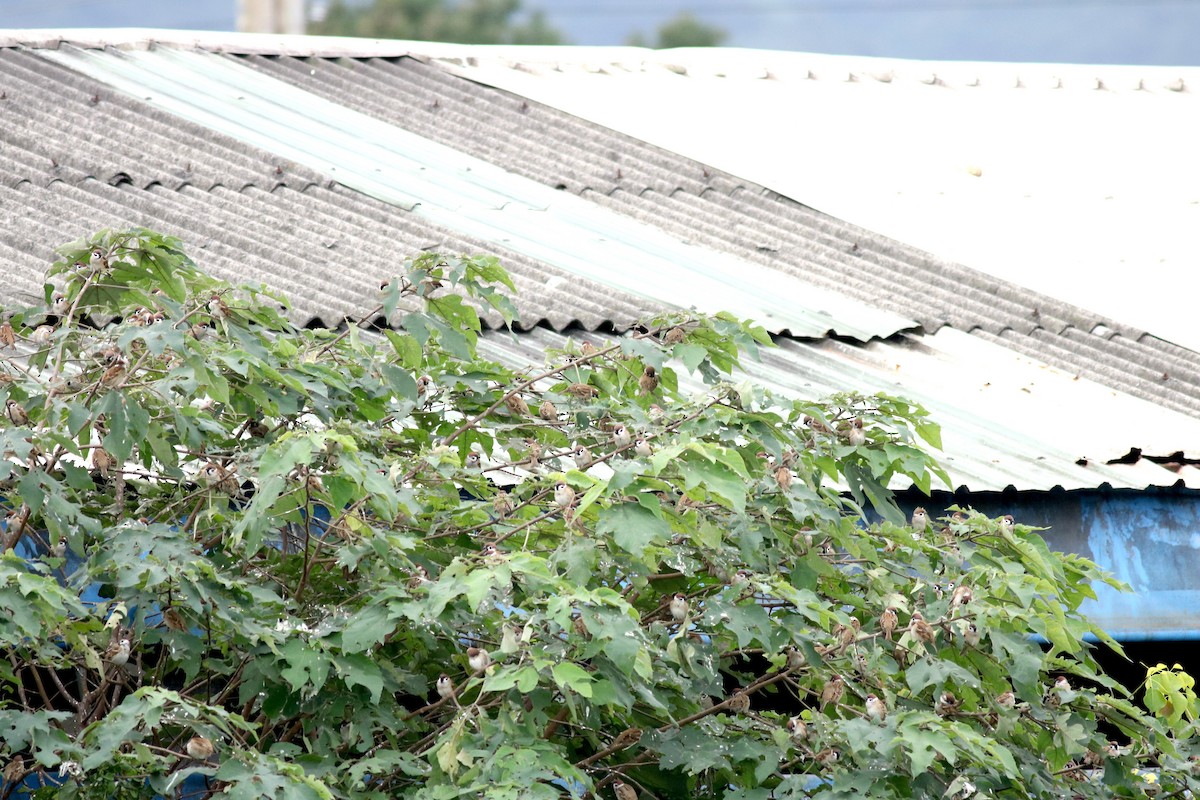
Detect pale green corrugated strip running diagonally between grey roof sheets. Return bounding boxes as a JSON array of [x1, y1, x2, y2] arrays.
[[44, 46, 916, 341]]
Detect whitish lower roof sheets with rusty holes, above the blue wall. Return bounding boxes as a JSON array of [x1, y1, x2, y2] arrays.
[[480, 329, 1200, 491]]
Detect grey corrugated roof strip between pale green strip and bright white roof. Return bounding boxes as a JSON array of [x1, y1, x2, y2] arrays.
[[245, 56, 1200, 416]]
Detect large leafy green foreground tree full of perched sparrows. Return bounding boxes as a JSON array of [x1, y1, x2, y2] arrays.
[[0, 230, 1198, 800]]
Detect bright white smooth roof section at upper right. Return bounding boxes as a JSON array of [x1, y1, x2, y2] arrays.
[[424, 46, 1200, 350]]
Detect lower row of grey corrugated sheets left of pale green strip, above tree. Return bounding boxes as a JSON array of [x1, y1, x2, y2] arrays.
[[0, 167, 655, 326]]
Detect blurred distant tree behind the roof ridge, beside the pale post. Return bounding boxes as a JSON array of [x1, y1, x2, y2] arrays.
[[310, 0, 563, 44]]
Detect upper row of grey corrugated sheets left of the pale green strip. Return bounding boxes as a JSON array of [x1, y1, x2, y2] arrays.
[[0, 50, 322, 188]]
